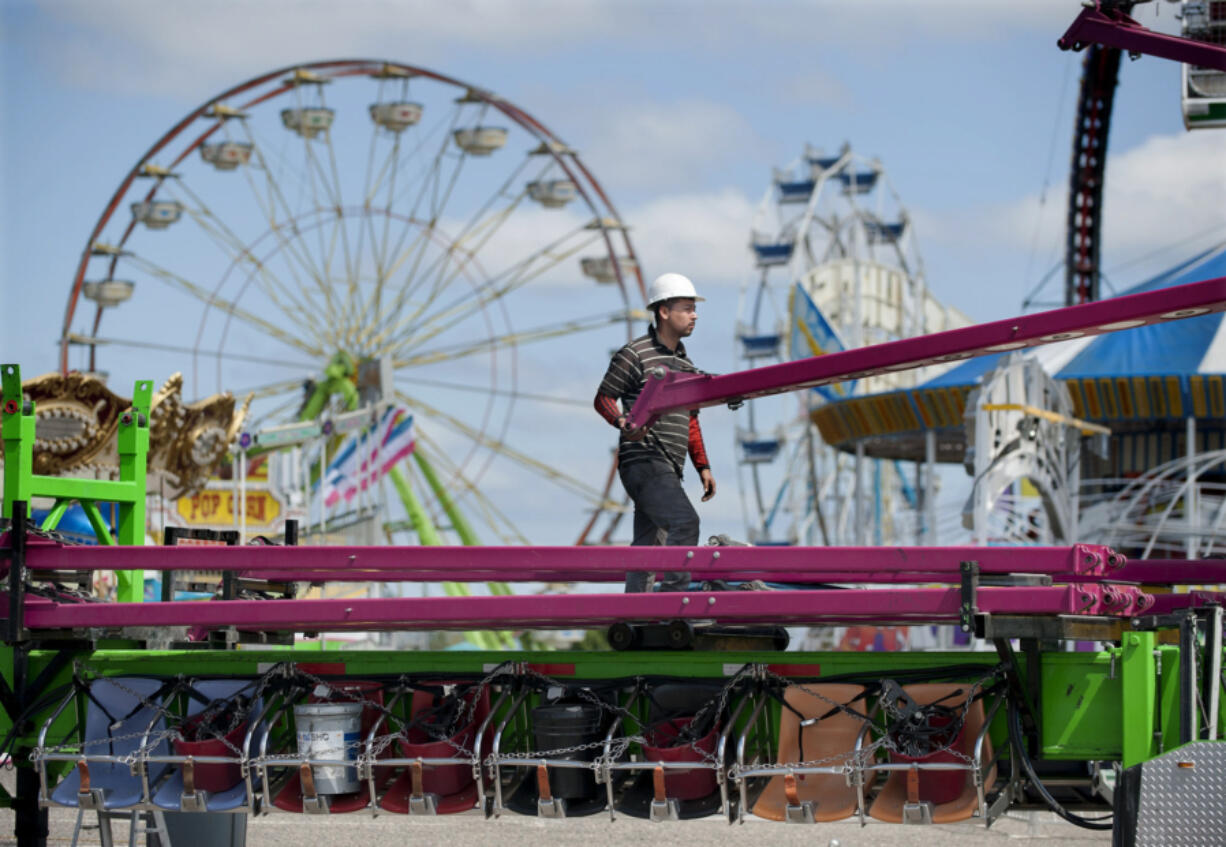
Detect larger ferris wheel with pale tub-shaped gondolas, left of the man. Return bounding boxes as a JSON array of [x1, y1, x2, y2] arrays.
[[60, 59, 642, 549]]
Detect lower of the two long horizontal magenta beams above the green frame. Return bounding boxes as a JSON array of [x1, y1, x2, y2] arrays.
[[7, 585, 1148, 631]]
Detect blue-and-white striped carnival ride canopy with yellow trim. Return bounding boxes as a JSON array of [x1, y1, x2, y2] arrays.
[[813, 243, 1226, 477]]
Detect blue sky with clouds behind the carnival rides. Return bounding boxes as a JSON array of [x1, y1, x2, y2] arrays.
[[0, 0, 1226, 542]]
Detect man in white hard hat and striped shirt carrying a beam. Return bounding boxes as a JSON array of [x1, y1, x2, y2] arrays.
[[596, 273, 715, 592]]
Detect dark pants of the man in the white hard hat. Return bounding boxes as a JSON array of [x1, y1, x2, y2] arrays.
[[618, 461, 699, 593]]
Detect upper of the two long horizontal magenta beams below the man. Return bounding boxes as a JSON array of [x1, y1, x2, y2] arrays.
[[9, 538, 1124, 582]]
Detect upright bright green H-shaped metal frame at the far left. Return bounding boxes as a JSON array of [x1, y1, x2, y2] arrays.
[[0, 364, 153, 603]]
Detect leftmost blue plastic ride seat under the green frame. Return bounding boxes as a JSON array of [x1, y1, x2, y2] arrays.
[[50, 678, 169, 810]]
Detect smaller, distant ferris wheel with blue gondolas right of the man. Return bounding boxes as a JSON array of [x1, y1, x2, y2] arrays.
[[736, 145, 946, 544]]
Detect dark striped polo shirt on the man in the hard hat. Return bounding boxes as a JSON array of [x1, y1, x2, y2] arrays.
[[598, 326, 698, 476]]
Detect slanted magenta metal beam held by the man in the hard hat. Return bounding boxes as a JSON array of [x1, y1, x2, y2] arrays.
[[629, 277, 1226, 427]]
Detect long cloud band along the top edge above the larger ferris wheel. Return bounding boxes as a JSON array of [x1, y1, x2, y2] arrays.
[[31, 0, 1123, 99]]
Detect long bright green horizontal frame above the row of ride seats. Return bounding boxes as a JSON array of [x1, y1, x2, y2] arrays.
[[0, 632, 1196, 766]]
